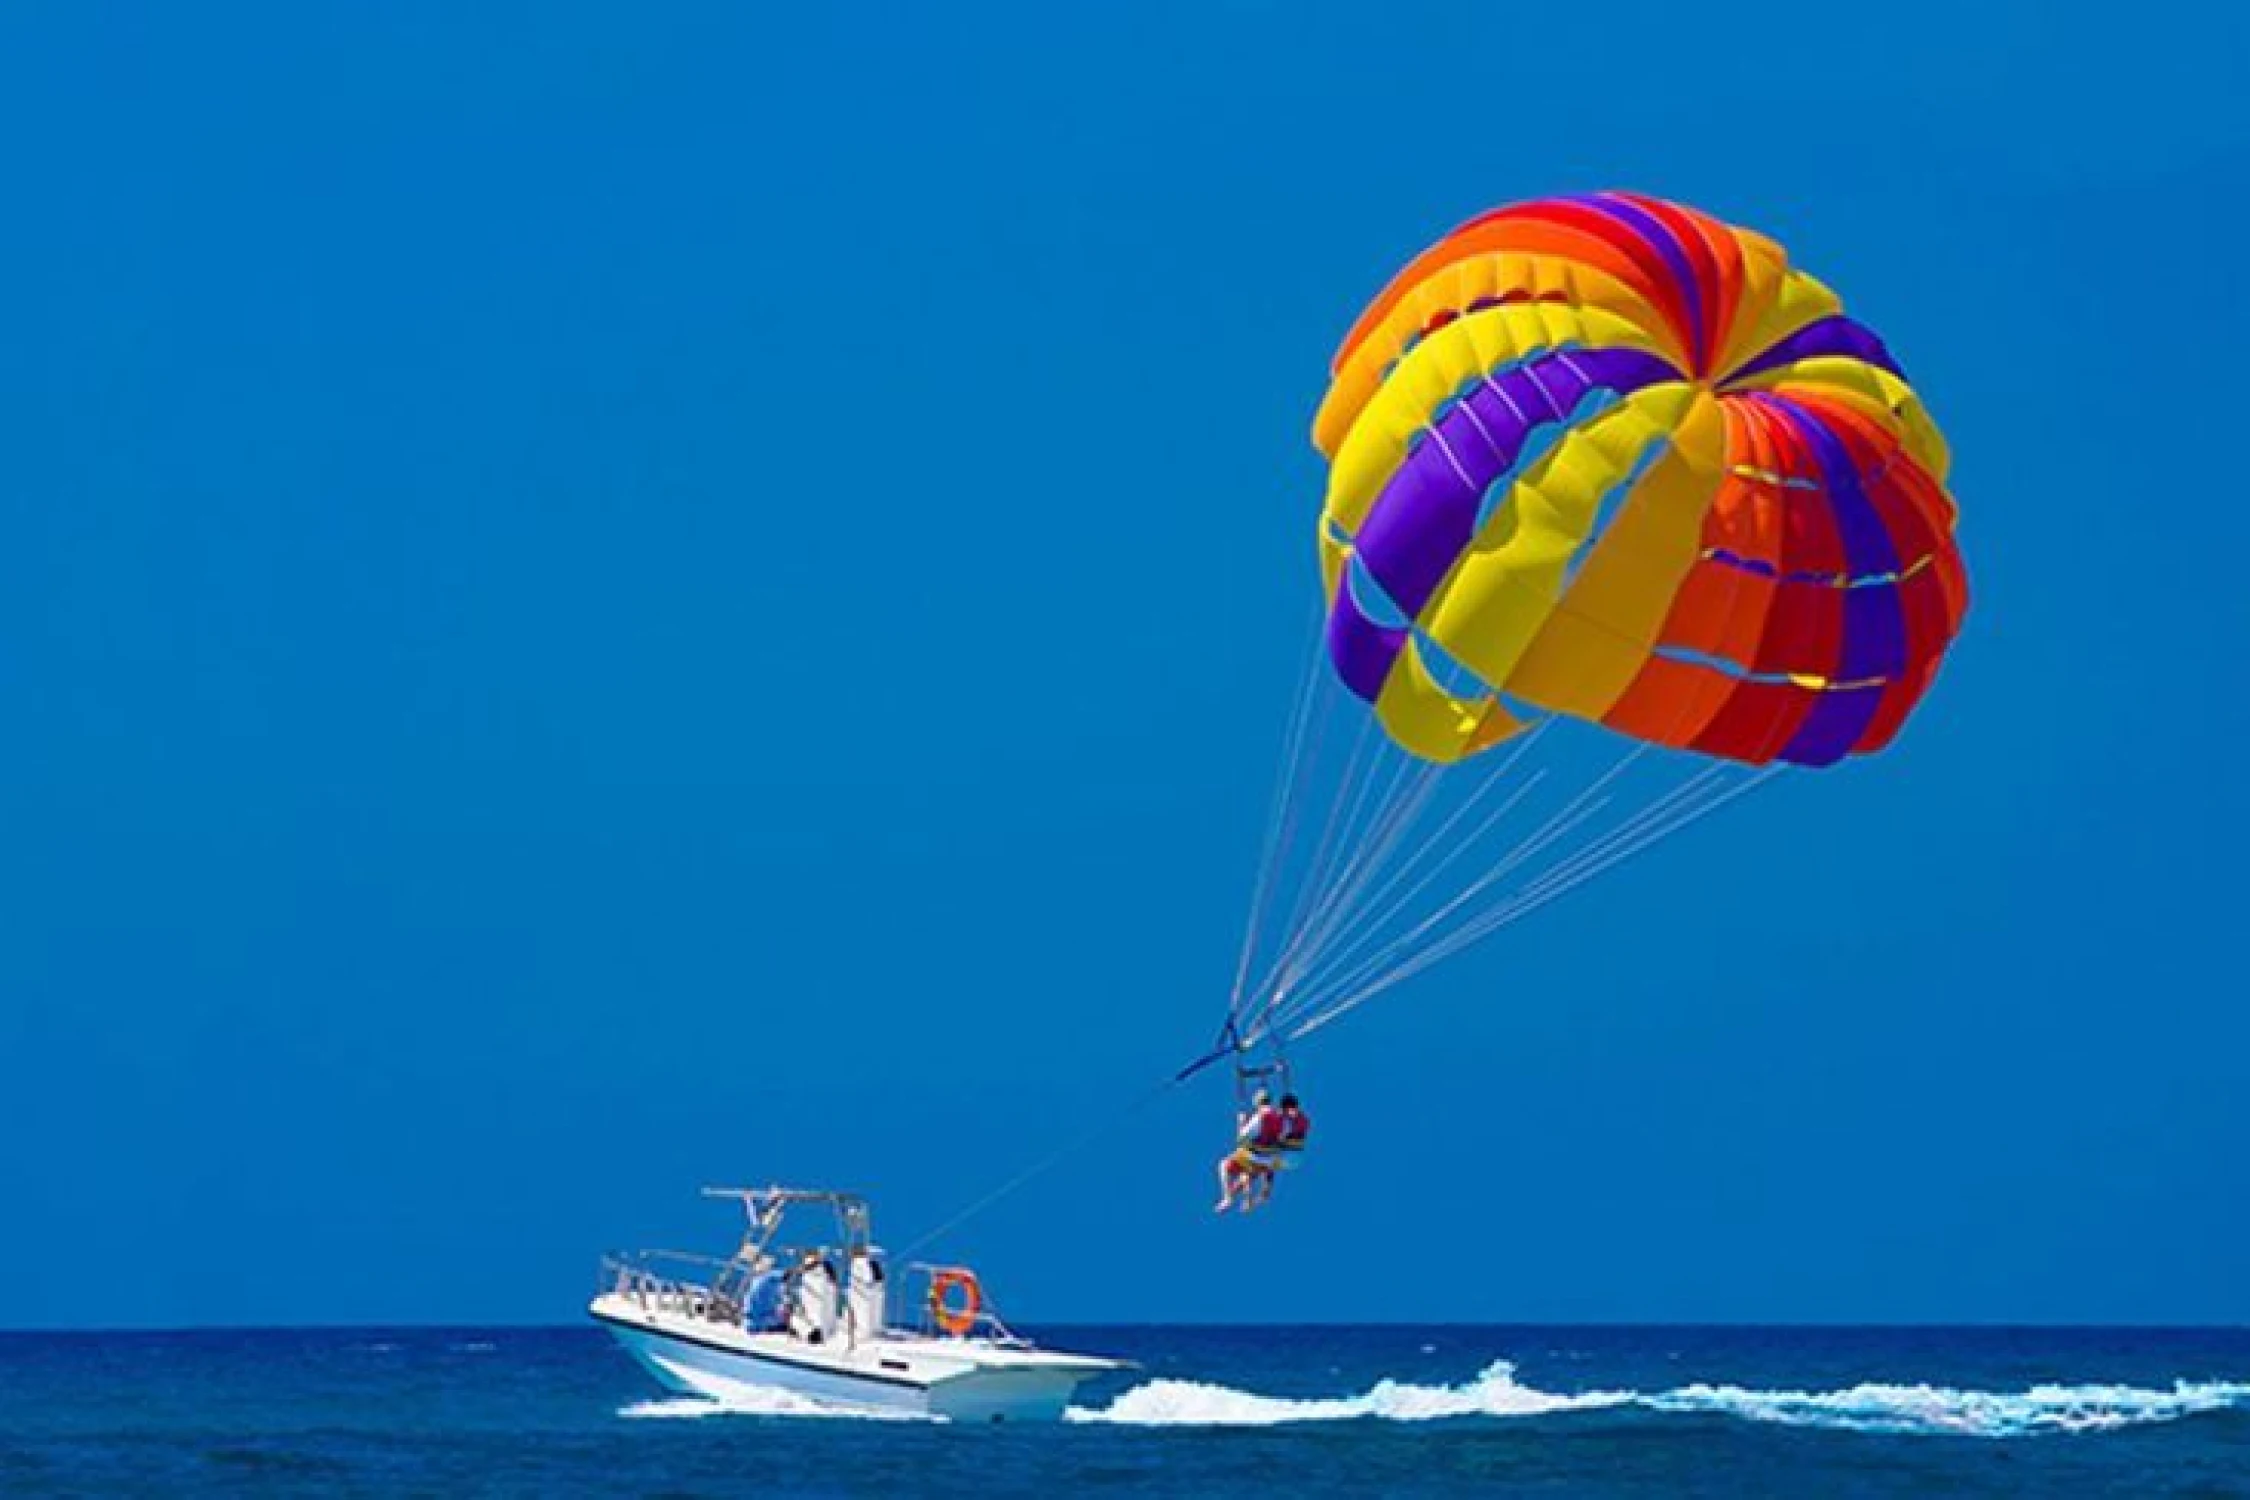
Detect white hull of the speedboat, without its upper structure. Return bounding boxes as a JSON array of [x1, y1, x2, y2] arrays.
[[587, 1295, 1118, 1421]]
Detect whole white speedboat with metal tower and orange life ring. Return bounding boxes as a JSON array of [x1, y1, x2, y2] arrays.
[[587, 1187, 1125, 1421]]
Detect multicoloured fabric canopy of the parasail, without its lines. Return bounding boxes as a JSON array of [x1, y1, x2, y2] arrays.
[[1314, 193, 1969, 765]]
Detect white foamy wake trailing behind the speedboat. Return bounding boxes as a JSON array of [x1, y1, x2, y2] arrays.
[[1067, 1361, 2250, 1437]]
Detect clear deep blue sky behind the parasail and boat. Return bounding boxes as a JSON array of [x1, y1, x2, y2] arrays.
[[0, 0, 2250, 1327]]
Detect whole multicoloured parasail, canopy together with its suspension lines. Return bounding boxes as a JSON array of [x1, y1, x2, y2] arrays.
[[1204, 193, 1969, 1068]]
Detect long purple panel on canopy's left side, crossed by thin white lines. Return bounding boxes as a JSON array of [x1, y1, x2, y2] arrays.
[[1357, 349, 1679, 618]]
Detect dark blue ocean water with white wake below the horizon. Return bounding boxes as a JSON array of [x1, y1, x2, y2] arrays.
[[0, 1327, 2250, 1500]]
